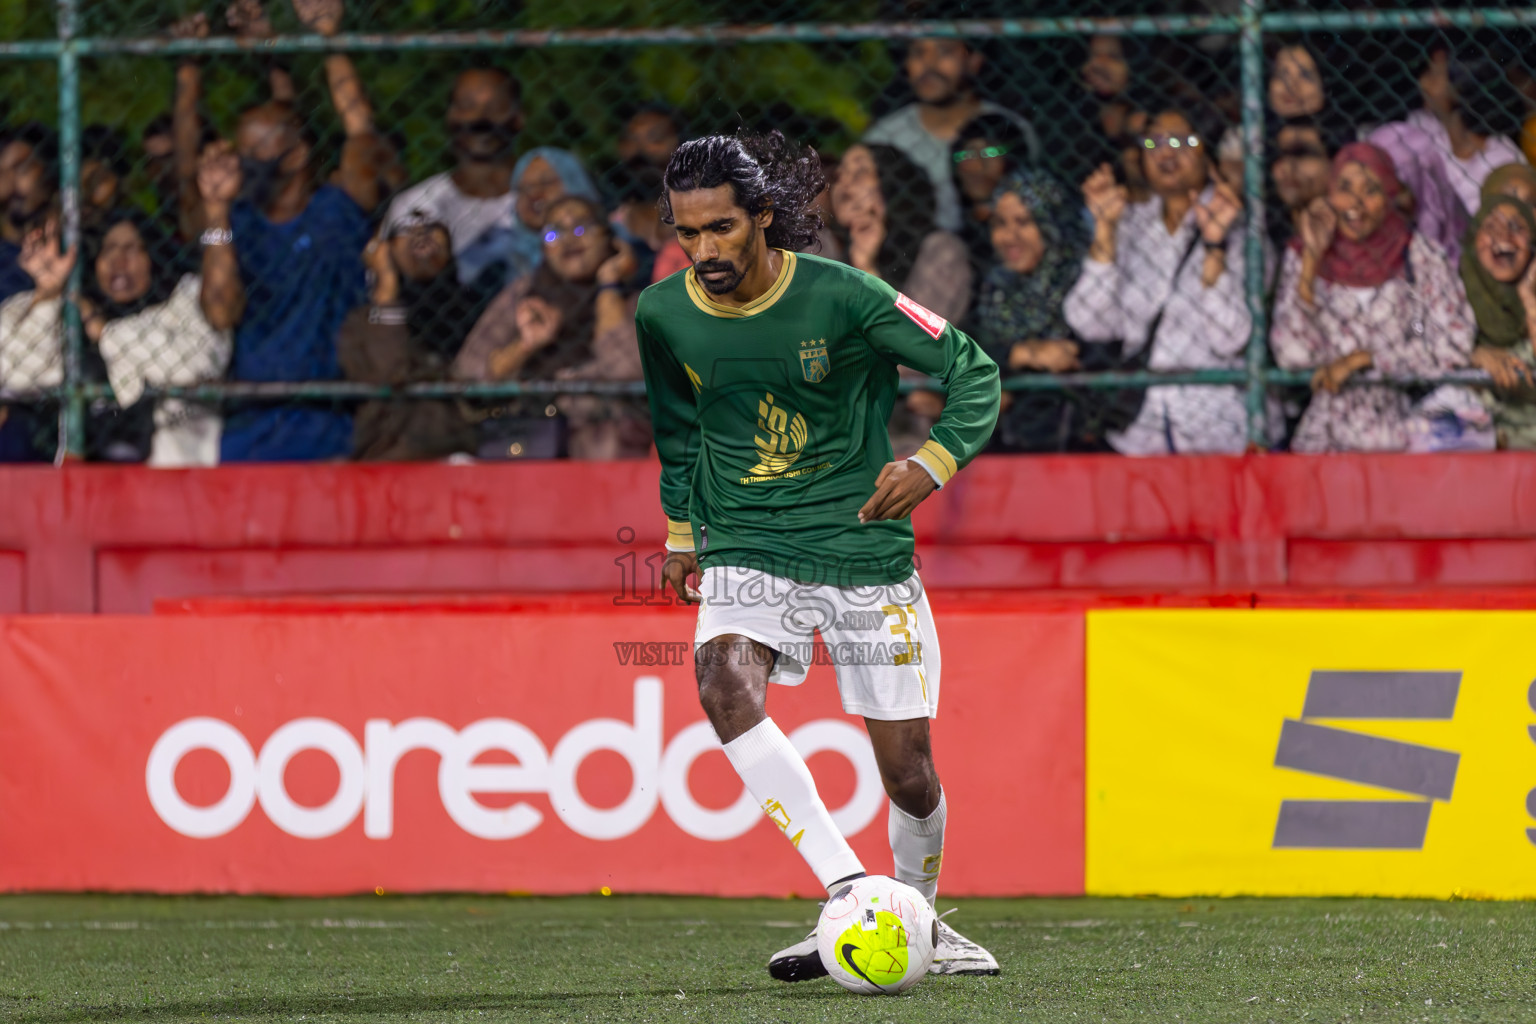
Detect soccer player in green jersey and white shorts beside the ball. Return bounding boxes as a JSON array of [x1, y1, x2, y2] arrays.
[[636, 132, 998, 981]]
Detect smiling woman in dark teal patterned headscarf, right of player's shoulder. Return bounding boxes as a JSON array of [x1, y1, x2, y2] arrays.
[[971, 167, 1092, 451]]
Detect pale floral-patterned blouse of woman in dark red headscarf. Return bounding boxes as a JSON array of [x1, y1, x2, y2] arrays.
[[1269, 232, 1476, 451]]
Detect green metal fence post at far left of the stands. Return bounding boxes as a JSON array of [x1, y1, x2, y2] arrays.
[[58, 0, 86, 459]]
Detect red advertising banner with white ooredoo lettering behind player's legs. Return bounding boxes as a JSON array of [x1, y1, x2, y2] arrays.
[[0, 599, 1083, 895]]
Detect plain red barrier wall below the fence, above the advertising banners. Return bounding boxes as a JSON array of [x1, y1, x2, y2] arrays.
[[0, 453, 1536, 613]]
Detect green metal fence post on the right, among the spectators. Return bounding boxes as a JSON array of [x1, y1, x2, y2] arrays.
[[1240, 0, 1269, 445]]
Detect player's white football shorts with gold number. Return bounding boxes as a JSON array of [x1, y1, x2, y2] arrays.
[[693, 565, 938, 722]]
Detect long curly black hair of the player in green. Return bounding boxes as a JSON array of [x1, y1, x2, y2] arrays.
[[659, 132, 826, 252]]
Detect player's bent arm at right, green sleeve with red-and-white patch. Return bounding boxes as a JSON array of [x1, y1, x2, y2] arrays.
[[854, 278, 1001, 509]]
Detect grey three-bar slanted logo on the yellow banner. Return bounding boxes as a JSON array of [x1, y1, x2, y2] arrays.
[[1273, 669, 1461, 851]]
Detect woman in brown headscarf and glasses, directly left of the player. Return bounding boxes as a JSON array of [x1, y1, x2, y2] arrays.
[[453, 197, 651, 459]]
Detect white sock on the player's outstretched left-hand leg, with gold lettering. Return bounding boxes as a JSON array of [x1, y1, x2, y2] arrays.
[[725, 718, 863, 886]]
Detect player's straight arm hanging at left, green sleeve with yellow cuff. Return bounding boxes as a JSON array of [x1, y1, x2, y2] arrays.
[[634, 293, 700, 600]]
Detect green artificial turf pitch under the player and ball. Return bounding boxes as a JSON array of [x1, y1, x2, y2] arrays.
[[0, 895, 1536, 1024]]
